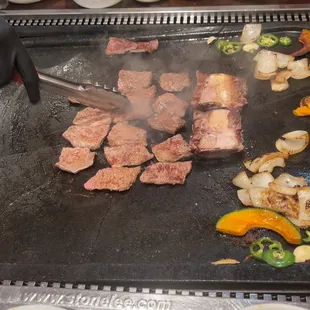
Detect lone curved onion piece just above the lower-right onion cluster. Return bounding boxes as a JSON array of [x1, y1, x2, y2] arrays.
[[276, 130, 309, 155]]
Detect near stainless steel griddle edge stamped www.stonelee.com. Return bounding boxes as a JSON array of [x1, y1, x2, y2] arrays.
[[0, 281, 310, 310]]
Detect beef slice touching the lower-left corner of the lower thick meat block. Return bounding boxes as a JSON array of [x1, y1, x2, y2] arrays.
[[152, 134, 192, 162]]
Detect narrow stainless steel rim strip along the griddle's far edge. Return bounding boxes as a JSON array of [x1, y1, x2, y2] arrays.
[[0, 4, 310, 16]]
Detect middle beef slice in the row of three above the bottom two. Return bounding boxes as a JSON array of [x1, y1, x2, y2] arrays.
[[104, 144, 154, 167]]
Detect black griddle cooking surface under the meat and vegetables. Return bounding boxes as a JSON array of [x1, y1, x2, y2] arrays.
[[0, 10, 310, 291]]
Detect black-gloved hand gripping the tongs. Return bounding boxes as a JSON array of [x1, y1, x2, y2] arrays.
[[0, 18, 40, 103]]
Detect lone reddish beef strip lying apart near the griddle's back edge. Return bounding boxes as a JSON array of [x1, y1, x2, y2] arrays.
[[105, 37, 159, 55]]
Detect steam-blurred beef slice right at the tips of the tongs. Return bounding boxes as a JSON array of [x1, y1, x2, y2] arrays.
[[126, 85, 157, 120]]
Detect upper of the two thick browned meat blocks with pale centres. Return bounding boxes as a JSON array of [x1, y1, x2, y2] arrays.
[[192, 71, 247, 111]]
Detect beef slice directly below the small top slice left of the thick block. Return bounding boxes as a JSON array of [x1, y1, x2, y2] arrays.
[[153, 93, 188, 117]]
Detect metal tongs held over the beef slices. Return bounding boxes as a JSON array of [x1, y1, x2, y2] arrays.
[[15, 71, 128, 111]]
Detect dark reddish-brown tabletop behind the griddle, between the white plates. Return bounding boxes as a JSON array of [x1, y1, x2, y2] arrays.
[[8, 0, 309, 10]]
